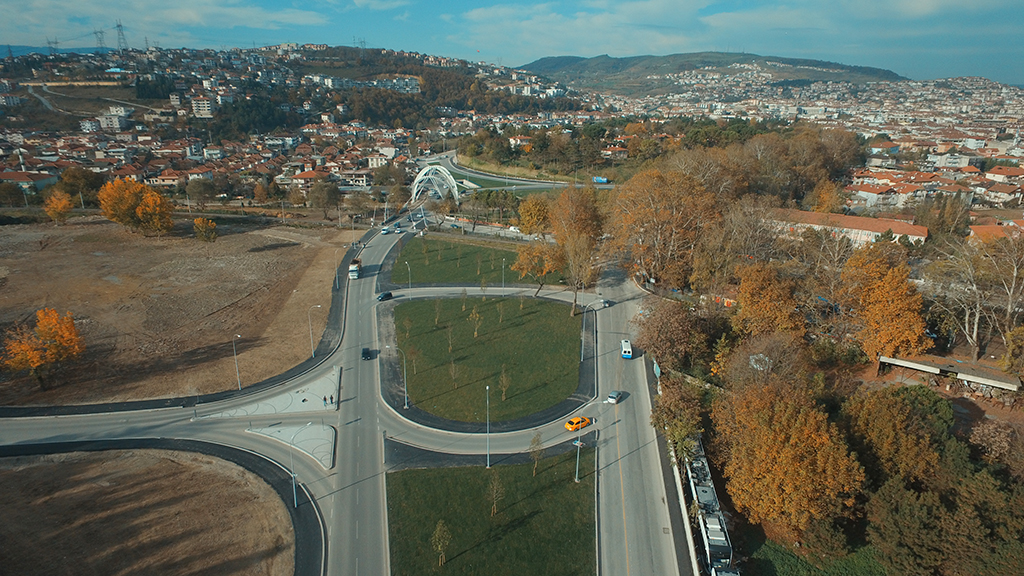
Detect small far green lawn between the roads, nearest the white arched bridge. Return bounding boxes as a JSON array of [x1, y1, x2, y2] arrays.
[[391, 235, 520, 284]]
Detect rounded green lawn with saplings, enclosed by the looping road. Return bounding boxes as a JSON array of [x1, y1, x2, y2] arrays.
[[394, 295, 581, 422]]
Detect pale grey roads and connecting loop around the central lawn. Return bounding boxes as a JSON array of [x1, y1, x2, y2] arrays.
[[0, 213, 689, 576]]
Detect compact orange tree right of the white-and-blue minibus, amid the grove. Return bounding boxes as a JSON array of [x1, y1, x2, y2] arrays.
[[732, 263, 804, 335]]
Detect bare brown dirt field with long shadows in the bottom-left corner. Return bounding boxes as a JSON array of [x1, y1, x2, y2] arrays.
[[0, 450, 295, 576]]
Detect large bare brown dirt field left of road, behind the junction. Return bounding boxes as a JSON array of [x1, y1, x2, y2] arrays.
[[0, 212, 361, 405]]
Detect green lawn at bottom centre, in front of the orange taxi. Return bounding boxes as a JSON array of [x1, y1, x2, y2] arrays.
[[387, 448, 596, 576]]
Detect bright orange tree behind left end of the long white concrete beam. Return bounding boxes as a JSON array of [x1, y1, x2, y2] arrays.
[[843, 243, 931, 358]]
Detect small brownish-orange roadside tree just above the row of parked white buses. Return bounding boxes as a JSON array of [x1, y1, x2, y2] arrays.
[[650, 377, 703, 463]]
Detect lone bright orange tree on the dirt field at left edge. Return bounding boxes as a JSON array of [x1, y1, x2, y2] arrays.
[[3, 307, 85, 386]]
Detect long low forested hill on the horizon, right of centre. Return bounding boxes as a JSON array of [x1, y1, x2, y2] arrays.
[[521, 52, 905, 95]]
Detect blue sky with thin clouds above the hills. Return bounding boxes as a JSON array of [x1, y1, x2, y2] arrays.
[[8, 0, 1024, 85]]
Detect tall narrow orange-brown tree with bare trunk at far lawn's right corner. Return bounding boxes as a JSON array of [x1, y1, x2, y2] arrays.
[[551, 188, 601, 316]]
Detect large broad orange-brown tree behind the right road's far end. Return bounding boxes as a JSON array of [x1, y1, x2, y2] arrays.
[[613, 170, 720, 287]]
